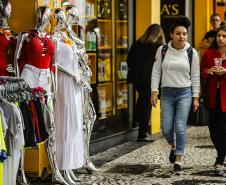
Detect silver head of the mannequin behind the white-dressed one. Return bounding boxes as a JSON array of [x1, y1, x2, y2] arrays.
[[65, 5, 79, 26]]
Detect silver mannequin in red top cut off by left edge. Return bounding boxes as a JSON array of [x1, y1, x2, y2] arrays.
[[0, 0, 16, 76]]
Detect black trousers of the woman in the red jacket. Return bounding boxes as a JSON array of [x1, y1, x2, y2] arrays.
[[209, 90, 226, 165]]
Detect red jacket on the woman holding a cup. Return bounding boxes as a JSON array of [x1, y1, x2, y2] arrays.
[[200, 49, 226, 112]]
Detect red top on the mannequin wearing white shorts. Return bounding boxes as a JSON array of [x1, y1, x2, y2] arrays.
[[19, 31, 54, 72]]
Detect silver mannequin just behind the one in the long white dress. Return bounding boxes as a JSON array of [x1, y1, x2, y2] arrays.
[[65, 5, 97, 173]]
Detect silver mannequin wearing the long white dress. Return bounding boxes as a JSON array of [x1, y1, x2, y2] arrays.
[[52, 8, 85, 184]]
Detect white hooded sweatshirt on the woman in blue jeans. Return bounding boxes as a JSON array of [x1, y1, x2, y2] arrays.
[[151, 41, 200, 97]]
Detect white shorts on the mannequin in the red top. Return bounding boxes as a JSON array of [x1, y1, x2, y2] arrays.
[[21, 64, 51, 94]]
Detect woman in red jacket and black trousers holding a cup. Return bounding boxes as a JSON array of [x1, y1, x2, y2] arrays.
[[201, 25, 226, 176]]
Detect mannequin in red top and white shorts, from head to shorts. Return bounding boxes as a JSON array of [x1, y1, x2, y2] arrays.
[[16, 6, 54, 93]]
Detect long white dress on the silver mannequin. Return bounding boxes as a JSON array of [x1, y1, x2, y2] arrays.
[[54, 41, 84, 170]]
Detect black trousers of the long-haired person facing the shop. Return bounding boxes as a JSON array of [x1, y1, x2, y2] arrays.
[[134, 85, 151, 137]]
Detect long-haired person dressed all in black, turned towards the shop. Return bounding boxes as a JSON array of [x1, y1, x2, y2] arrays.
[[127, 24, 165, 142]]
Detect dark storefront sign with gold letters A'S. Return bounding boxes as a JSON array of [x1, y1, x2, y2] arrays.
[[161, 0, 186, 42]]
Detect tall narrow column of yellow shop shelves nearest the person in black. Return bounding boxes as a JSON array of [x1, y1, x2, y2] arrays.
[[115, 0, 128, 114]]
